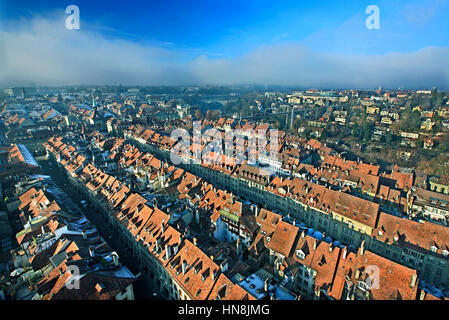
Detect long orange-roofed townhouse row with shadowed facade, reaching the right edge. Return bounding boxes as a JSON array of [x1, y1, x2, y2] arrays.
[[124, 125, 449, 290]]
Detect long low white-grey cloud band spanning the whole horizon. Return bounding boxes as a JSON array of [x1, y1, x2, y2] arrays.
[[0, 15, 449, 88]]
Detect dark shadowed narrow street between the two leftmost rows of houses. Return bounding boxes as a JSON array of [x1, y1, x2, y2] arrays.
[[38, 160, 162, 300]]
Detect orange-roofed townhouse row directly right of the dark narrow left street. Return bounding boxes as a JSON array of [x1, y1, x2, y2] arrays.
[[45, 139, 254, 300]]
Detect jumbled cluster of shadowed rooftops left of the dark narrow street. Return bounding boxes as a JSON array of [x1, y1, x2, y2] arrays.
[[8, 180, 137, 300]]
